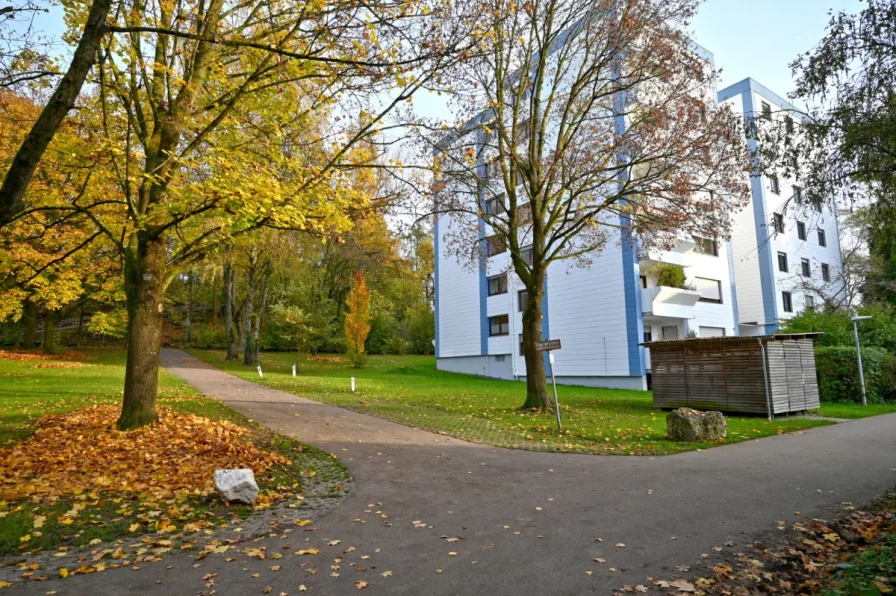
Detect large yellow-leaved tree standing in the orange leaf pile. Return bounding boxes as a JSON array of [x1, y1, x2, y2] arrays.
[[0, 0, 476, 429]]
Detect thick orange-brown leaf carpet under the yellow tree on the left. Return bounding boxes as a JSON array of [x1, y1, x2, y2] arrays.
[[0, 405, 289, 500]]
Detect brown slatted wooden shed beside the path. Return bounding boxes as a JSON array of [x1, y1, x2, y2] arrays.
[[641, 333, 820, 418]]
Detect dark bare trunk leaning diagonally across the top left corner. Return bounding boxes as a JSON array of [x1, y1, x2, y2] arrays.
[[0, 0, 112, 226]]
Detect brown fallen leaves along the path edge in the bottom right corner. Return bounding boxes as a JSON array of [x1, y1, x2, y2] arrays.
[[636, 493, 896, 596]]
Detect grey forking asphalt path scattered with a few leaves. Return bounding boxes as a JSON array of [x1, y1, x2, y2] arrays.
[[9, 350, 896, 596]]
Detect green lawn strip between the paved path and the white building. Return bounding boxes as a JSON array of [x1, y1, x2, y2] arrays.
[[192, 350, 876, 455]]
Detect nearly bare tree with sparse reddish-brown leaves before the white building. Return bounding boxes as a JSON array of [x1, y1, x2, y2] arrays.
[[427, 0, 750, 410]]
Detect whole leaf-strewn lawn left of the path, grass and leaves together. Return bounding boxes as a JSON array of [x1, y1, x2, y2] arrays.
[[0, 350, 348, 560]]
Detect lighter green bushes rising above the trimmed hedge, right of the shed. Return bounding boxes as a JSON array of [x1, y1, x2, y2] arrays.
[[781, 305, 896, 354]]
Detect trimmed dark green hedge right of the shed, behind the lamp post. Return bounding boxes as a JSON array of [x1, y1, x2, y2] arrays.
[[815, 346, 896, 403]]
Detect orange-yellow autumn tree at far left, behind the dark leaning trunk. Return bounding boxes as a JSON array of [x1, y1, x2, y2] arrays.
[[0, 86, 123, 353]]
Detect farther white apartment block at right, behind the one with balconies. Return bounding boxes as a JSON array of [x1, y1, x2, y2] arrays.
[[718, 78, 843, 335]]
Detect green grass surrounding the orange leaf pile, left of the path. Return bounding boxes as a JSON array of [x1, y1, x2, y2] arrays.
[[0, 349, 349, 563]]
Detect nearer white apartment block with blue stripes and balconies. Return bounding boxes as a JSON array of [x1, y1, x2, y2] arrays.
[[434, 48, 737, 389]]
